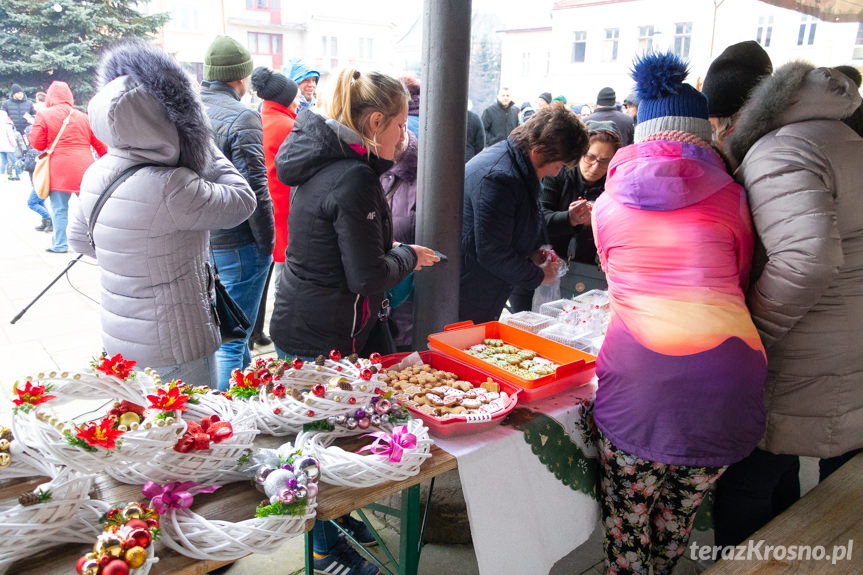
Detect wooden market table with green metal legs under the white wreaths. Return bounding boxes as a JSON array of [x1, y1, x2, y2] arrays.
[[0, 444, 456, 575]]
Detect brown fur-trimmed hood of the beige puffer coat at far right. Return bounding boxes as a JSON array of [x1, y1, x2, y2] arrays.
[[726, 61, 861, 165]]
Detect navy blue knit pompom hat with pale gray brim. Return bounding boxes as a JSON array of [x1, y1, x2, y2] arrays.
[[632, 52, 713, 143]]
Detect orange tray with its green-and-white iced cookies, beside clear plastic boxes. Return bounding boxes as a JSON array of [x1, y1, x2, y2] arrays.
[[429, 321, 596, 402]]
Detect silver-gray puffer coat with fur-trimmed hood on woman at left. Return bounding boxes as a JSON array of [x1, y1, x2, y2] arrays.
[[69, 41, 255, 387]]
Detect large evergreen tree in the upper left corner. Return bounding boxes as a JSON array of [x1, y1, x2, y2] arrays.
[[0, 0, 170, 103]]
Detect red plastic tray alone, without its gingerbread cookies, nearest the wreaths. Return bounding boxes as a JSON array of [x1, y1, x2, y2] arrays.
[[381, 350, 523, 437]]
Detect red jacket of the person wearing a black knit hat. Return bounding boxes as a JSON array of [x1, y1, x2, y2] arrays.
[[261, 100, 297, 262]]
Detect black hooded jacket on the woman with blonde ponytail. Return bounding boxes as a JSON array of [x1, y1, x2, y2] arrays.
[[270, 109, 417, 356]]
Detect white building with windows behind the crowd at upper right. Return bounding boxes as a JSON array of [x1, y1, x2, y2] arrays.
[[501, 0, 863, 104]]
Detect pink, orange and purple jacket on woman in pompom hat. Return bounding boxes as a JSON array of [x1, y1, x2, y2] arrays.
[[593, 140, 767, 467]]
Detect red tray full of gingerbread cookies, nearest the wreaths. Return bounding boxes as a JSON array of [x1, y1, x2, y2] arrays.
[[378, 350, 521, 437]]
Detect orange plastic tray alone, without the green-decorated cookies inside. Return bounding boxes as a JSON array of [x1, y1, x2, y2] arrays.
[[429, 321, 596, 403]]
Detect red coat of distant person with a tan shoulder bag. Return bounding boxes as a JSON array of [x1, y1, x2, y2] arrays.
[[30, 81, 108, 194]]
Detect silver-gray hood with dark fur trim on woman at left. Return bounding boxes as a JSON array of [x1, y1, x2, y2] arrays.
[[88, 40, 212, 174]]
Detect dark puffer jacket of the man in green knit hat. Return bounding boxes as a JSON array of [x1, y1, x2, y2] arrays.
[[201, 82, 276, 254]]
